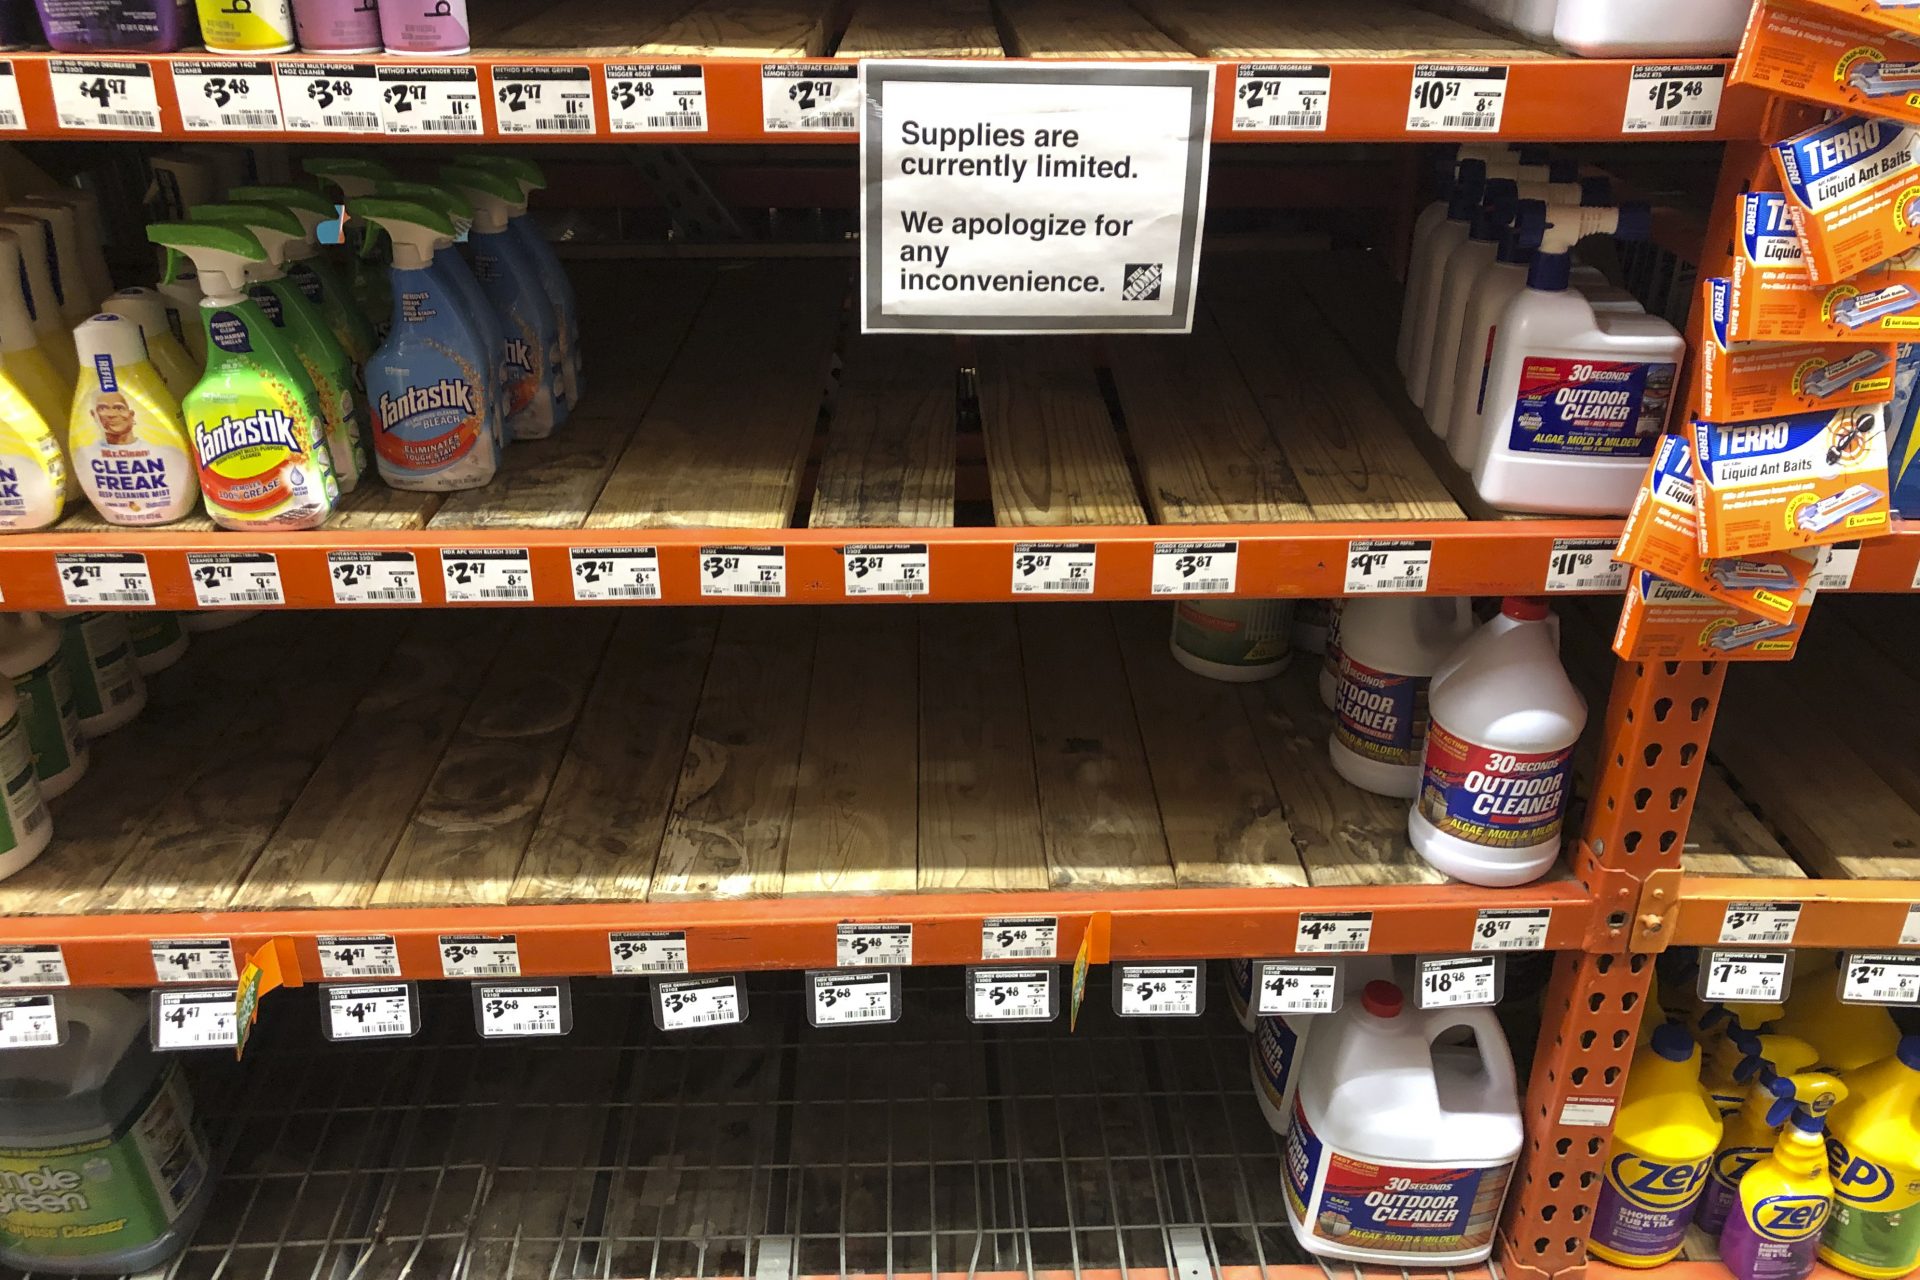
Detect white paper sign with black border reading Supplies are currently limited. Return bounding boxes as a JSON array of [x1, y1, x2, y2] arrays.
[[860, 59, 1213, 334]]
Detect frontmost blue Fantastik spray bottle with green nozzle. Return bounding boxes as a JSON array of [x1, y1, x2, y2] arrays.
[[348, 196, 499, 491]]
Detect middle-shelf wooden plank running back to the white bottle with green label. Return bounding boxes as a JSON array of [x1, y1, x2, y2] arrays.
[[1112, 604, 1308, 889]]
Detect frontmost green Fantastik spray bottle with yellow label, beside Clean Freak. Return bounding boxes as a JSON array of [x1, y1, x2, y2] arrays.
[[146, 223, 340, 530]]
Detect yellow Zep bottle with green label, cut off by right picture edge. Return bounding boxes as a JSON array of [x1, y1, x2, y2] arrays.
[[1820, 1036, 1920, 1280]]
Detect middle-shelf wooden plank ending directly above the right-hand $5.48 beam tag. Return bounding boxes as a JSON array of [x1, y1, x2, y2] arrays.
[[920, 604, 1050, 892]]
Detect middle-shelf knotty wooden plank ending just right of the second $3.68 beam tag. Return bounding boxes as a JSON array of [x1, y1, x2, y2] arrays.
[[647, 608, 818, 900]]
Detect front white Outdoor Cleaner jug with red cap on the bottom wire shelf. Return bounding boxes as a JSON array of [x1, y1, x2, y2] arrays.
[[1284, 981, 1524, 1268]]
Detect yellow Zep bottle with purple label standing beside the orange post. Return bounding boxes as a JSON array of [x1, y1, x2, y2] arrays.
[[1588, 1023, 1720, 1267]]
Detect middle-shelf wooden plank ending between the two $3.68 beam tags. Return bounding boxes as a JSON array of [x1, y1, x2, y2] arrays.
[[513, 608, 720, 902]]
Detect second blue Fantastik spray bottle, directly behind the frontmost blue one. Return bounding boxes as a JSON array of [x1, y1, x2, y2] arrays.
[[440, 165, 566, 439]]
